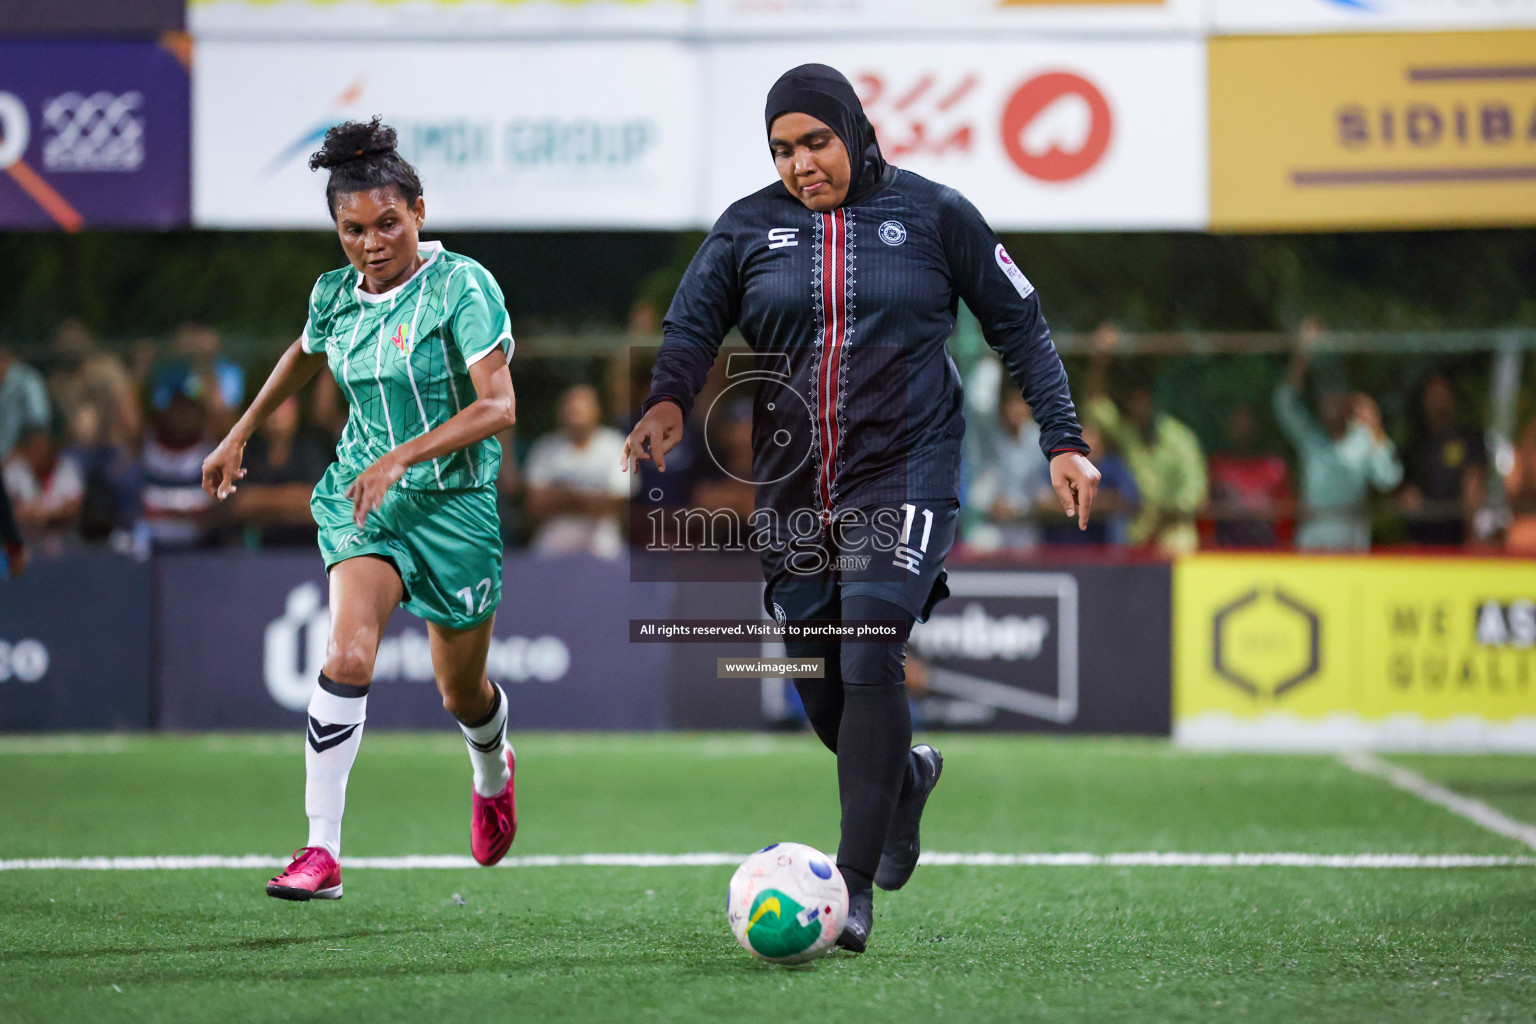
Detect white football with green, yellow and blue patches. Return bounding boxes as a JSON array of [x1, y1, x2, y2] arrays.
[[725, 843, 848, 964]]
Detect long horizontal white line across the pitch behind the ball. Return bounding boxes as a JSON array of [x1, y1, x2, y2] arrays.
[[0, 852, 1536, 870]]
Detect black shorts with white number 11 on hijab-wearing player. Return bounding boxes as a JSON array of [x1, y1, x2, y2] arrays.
[[762, 500, 960, 622]]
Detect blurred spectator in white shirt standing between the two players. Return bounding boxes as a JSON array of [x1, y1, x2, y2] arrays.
[[524, 384, 630, 557]]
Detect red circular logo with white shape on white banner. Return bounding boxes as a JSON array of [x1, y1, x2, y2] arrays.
[[1003, 71, 1111, 181]]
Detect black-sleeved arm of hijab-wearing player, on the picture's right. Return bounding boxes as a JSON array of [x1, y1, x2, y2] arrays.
[[938, 192, 1098, 530]]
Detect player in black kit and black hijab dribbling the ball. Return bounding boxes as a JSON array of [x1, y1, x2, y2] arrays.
[[624, 64, 1098, 952]]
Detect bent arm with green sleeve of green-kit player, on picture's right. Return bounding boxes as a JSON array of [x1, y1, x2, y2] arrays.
[[347, 267, 518, 527]]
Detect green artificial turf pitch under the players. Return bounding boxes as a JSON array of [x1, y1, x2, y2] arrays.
[[0, 734, 1536, 1024]]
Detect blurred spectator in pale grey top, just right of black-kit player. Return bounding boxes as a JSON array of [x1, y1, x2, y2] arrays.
[[966, 376, 1050, 551]]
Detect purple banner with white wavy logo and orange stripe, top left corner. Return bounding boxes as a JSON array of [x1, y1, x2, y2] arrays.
[[0, 41, 190, 232]]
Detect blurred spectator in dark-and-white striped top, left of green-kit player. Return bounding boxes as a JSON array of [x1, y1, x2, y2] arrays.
[[140, 378, 214, 548]]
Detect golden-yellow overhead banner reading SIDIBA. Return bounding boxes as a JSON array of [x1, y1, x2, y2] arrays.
[[1209, 32, 1536, 230]]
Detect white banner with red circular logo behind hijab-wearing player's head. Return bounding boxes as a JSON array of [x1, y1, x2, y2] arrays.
[[707, 40, 1207, 230]]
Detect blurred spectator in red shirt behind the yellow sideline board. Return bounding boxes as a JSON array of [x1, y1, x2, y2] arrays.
[[1210, 404, 1292, 548]]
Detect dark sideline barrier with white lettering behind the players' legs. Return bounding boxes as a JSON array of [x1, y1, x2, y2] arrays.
[[0, 553, 1170, 735]]
